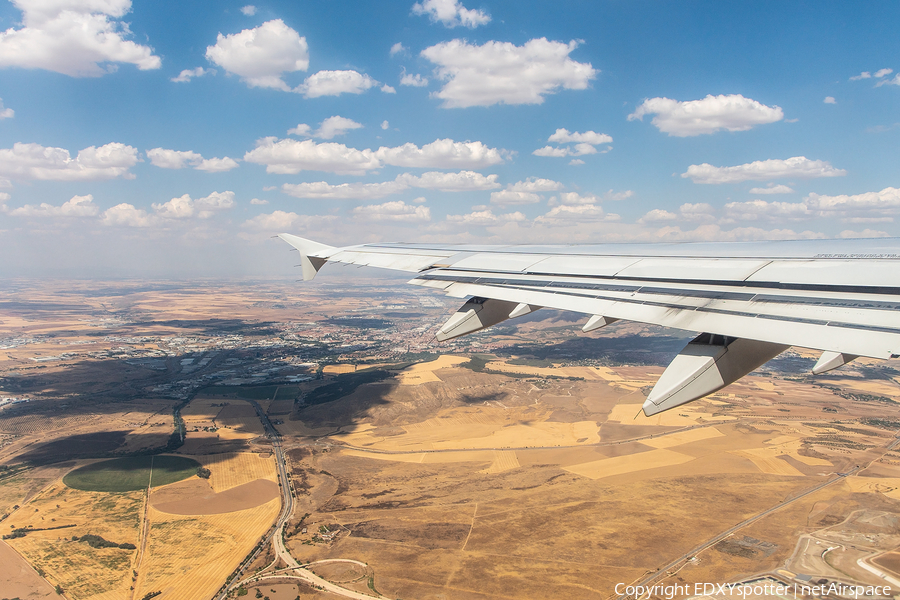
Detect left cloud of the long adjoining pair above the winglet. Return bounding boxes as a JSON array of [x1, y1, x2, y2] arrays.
[[244, 137, 382, 175]]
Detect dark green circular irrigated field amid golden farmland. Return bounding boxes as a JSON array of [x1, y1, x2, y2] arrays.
[[63, 456, 200, 492]]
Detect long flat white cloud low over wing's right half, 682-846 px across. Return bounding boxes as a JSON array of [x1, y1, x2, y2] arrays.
[[681, 156, 847, 184]]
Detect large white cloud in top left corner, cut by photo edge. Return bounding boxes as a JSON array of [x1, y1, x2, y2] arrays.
[[0, 0, 162, 77]]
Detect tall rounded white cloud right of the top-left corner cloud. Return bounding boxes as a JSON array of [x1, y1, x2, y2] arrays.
[[206, 19, 309, 92]]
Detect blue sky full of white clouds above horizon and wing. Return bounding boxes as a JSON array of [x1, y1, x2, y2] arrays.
[[0, 0, 900, 277]]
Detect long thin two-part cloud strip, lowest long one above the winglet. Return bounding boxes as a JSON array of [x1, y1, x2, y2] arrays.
[[282, 171, 500, 200]]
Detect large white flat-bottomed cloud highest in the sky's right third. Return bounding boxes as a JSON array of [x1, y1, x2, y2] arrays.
[[628, 94, 784, 137]]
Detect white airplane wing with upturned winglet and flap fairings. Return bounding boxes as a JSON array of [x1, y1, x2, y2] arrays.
[[279, 233, 900, 416]]
